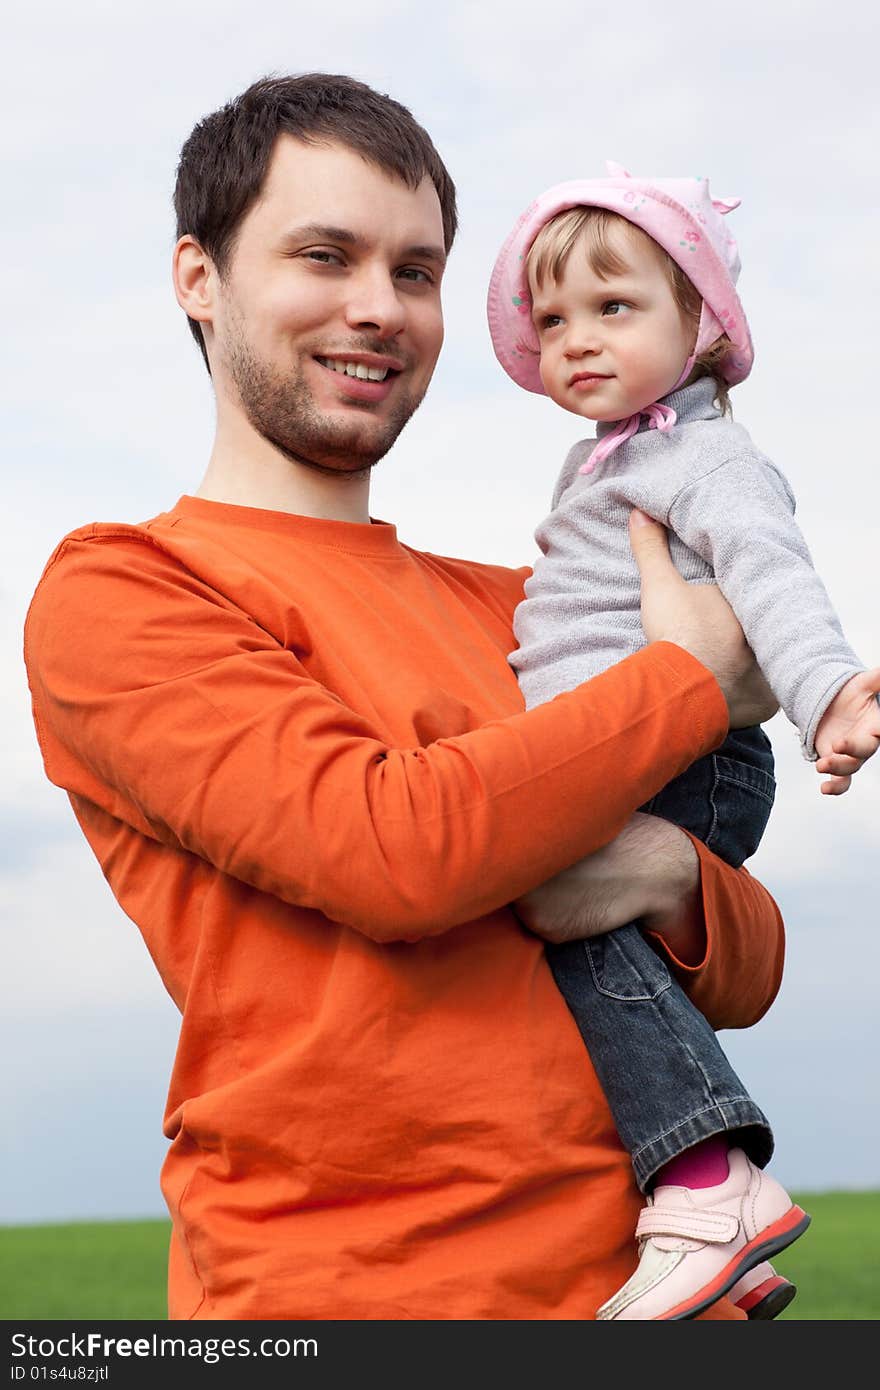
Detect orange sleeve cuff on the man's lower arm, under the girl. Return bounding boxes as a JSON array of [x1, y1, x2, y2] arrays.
[[652, 835, 785, 1029]]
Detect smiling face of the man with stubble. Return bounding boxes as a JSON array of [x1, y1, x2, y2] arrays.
[[209, 135, 445, 473]]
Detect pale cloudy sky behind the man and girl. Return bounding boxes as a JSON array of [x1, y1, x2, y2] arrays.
[[0, 0, 880, 1222]]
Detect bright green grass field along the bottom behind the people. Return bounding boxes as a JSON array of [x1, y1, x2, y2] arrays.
[[0, 1193, 880, 1322]]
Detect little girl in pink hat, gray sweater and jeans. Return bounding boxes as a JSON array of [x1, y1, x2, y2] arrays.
[[488, 164, 880, 1321]]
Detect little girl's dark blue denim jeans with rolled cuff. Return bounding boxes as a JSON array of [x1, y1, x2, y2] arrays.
[[546, 727, 776, 1191]]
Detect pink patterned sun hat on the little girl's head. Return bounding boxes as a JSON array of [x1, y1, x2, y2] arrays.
[[488, 161, 753, 403]]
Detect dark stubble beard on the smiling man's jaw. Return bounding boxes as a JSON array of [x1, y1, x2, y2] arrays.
[[224, 312, 424, 477]]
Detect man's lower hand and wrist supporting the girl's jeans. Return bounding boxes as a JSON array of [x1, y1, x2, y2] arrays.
[[513, 812, 702, 959]]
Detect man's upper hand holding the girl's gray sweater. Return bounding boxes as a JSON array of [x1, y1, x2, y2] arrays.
[[630, 510, 779, 728]]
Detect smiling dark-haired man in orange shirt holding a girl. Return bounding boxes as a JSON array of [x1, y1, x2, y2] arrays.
[[26, 74, 783, 1319]]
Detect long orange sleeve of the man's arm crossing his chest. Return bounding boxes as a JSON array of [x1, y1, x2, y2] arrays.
[[25, 538, 727, 941]]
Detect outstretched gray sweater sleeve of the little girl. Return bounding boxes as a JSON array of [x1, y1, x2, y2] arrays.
[[669, 453, 865, 760]]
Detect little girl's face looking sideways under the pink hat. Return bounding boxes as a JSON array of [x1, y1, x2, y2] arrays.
[[530, 224, 696, 420]]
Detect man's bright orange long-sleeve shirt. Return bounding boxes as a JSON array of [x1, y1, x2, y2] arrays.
[[25, 498, 783, 1319]]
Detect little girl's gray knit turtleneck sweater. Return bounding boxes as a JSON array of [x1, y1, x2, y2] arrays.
[[510, 379, 865, 759]]
